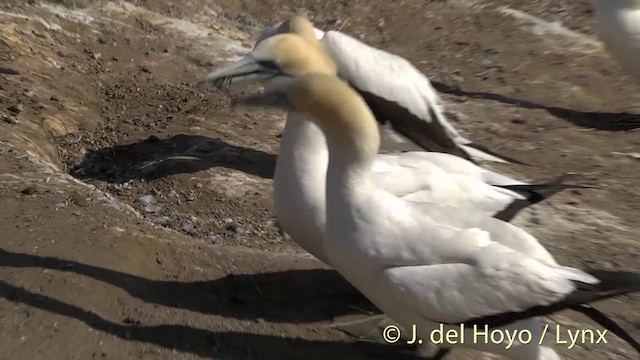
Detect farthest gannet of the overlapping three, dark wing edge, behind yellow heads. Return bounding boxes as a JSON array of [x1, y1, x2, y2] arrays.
[[255, 16, 523, 164]]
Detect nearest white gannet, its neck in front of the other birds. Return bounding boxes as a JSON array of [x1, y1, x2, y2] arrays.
[[237, 73, 640, 360]]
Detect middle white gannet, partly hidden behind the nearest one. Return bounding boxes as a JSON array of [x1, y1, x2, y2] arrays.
[[200, 34, 577, 264]]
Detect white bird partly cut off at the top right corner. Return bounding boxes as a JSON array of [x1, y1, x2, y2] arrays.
[[595, 0, 640, 79]]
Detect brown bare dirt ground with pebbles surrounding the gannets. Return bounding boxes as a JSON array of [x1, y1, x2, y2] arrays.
[[0, 0, 640, 360]]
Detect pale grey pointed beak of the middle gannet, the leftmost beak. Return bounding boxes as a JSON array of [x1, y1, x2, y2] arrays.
[[198, 55, 283, 89]]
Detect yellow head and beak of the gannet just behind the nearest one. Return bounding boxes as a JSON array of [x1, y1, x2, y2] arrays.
[[199, 32, 337, 88]]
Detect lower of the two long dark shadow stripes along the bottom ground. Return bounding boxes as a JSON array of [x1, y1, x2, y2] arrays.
[[0, 281, 418, 360]]
